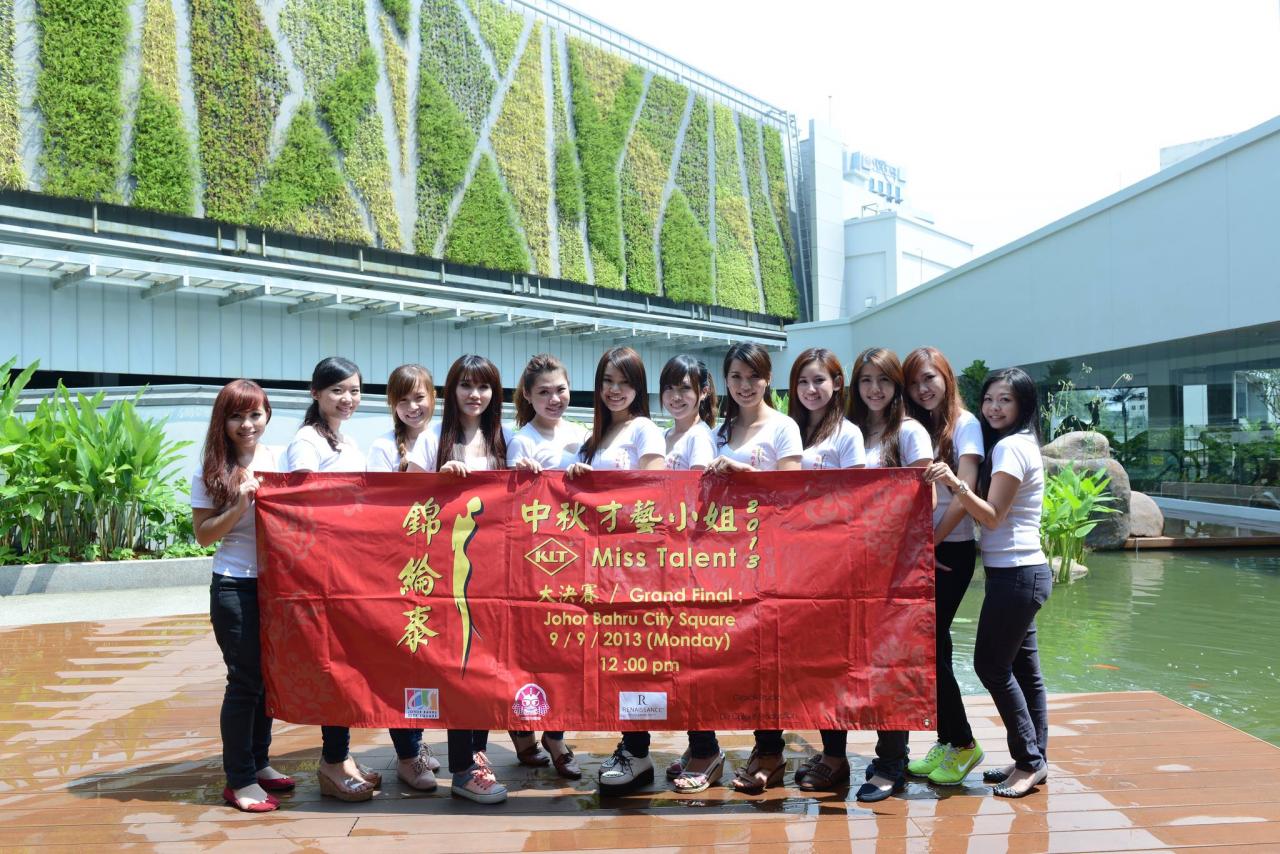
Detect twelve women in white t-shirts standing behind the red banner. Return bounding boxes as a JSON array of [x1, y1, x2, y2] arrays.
[[191, 343, 1051, 812]]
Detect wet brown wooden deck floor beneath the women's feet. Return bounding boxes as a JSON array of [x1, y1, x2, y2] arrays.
[[0, 616, 1280, 853]]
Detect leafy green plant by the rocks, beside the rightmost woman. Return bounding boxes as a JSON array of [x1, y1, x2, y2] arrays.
[[1041, 466, 1120, 584]]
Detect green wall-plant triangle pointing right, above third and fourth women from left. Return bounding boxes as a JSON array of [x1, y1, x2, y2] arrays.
[[415, 64, 476, 255]]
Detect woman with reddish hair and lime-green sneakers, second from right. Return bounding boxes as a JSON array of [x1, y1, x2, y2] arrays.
[[902, 347, 984, 786]]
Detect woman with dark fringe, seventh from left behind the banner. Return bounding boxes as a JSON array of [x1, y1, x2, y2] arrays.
[[658, 355, 724, 794]]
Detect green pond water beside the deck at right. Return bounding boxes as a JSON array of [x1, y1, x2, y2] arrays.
[[952, 548, 1280, 745]]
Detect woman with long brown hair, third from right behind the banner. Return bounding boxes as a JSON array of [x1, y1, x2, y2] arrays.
[[849, 347, 933, 803]]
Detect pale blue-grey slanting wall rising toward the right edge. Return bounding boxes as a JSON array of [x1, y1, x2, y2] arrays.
[[782, 118, 1280, 366]]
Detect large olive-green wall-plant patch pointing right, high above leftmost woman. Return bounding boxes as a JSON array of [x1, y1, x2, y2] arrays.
[[191, 0, 284, 223]]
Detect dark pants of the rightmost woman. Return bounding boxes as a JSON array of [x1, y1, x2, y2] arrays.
[[973, 563, 1053, 771]]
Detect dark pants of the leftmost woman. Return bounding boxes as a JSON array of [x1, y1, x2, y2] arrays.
[[209, 575, 271, 789]]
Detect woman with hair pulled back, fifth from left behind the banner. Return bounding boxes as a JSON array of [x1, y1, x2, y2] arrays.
[[507, 353, 590, 780]]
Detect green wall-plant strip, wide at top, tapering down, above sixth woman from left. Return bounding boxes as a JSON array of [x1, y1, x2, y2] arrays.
[[568, 38, 644, 288]]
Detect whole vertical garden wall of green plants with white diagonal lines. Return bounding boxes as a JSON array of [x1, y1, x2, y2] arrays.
[[10, 0, 797, 316]]
